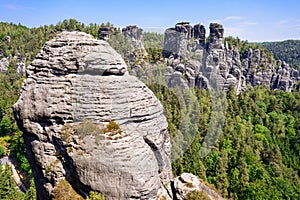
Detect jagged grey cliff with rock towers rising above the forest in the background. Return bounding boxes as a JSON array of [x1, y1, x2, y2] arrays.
[[163, 22, 300, 92]]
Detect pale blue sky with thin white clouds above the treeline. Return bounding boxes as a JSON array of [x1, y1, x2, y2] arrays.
[[0, 0, 300, 41]]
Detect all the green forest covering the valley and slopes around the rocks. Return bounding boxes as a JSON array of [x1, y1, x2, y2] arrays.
[[0, 19, 300, 200]]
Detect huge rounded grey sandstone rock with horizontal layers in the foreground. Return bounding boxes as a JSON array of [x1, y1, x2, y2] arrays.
[[14, 32, 172, 200]]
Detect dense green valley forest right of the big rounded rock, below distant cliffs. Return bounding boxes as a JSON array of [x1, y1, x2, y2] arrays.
[[154, 85, 300, 199]]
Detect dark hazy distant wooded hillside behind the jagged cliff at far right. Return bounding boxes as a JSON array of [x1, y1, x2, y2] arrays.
[[258, 40, 300, 70]]
